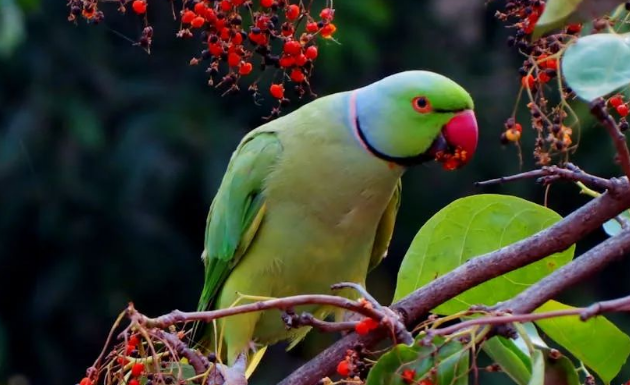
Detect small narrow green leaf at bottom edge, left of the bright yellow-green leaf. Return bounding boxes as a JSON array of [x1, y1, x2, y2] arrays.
[[481, 336, 532, 385]]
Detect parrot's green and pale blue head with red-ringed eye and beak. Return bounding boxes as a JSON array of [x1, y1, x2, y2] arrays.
[[351, 71, 478, 170]]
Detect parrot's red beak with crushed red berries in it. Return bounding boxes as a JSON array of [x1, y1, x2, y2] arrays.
[[432, 110, 479, 170]]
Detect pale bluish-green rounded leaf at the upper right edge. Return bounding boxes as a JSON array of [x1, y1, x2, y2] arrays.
[[562, 33, 630, 101]]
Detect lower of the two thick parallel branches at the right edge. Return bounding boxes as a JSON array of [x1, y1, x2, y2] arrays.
[[506, 231, 630, 314]]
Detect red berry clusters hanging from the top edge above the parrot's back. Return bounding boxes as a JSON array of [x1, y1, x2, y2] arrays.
[[68, 0, 337, 118]]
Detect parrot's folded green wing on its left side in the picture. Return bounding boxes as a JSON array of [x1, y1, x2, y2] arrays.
[[198, 131, 282, 311]]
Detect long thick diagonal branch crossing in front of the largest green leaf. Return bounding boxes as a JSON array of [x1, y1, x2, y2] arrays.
[[280, 179, 630, 385]]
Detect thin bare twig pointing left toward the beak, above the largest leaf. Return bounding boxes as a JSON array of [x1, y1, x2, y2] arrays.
[[475, 163, 614, 190]]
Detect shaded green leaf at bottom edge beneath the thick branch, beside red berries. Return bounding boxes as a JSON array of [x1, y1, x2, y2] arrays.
[[366, 335, 469, 385]]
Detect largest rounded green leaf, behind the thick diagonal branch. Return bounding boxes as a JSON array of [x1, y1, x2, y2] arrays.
[[394, 194, 574, 314]]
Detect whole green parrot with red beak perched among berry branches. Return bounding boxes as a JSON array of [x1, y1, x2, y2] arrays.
[[198, 70, 478, 376]]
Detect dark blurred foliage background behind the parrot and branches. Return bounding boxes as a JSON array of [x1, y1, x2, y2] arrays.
[[0, 0, 630, 385]]
